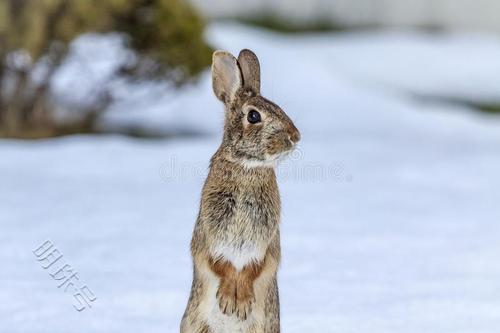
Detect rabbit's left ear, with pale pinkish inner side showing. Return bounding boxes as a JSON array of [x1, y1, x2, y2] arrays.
[[212, 51, 243, 103]]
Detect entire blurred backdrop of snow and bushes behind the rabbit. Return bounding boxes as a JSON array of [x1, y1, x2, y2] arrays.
[[0, 0, 500, 333]]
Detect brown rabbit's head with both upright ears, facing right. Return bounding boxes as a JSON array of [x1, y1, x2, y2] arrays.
[[212, 50, 300, 167]]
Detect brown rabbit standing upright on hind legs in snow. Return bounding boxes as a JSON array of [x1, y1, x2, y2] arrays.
[[180, 49, 300, 333]]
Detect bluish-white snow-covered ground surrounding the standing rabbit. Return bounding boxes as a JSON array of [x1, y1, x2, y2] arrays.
[[0, 25, 500, 333]]
